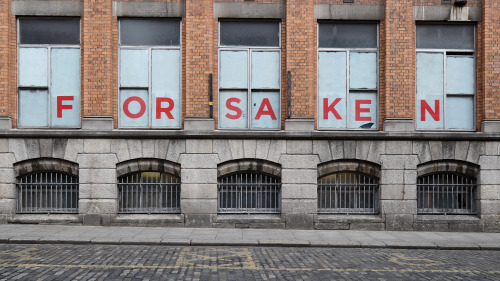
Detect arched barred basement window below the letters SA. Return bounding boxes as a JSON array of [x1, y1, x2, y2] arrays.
[[217, 160, 281, 213]]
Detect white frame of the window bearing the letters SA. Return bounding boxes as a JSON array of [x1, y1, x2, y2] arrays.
[[217, 21, 282, 131]]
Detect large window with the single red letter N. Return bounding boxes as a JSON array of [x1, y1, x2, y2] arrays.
[[416, 24, 476, 130]]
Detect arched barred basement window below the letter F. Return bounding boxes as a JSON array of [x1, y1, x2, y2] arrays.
[[14, 158, 78, 213]]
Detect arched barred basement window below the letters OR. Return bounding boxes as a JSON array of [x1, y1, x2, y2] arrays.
[[117, 159, 181, 214]]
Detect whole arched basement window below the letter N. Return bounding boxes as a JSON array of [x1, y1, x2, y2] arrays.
[[417, 161, 479, 214]]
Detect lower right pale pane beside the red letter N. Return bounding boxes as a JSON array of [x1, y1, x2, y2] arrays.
[[446, 97, 474, 130]]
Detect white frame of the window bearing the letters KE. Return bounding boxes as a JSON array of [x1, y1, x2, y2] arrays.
[[316, 22, 380, 131]]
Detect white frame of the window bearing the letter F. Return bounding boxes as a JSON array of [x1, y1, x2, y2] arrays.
[[17, 16, 82, 129]]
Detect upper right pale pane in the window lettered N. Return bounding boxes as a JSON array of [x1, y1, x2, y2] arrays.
[[446, 57, 475, 94]]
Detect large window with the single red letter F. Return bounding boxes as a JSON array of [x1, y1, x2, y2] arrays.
[[18, 17, 80, 127]]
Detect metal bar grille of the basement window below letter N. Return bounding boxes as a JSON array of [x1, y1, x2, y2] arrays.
[[417, 173, 476, 214]]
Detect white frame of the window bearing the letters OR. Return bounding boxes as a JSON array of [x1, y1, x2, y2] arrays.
[[117, 17, 182, 130]]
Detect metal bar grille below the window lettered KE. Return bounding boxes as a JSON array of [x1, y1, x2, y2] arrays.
[[318, 173, 379, 214]]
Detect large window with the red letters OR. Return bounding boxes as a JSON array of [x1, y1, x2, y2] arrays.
[[119, 18, 181, 128]]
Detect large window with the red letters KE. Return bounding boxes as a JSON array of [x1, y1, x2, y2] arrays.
[[318, 23, 378, 129]]
